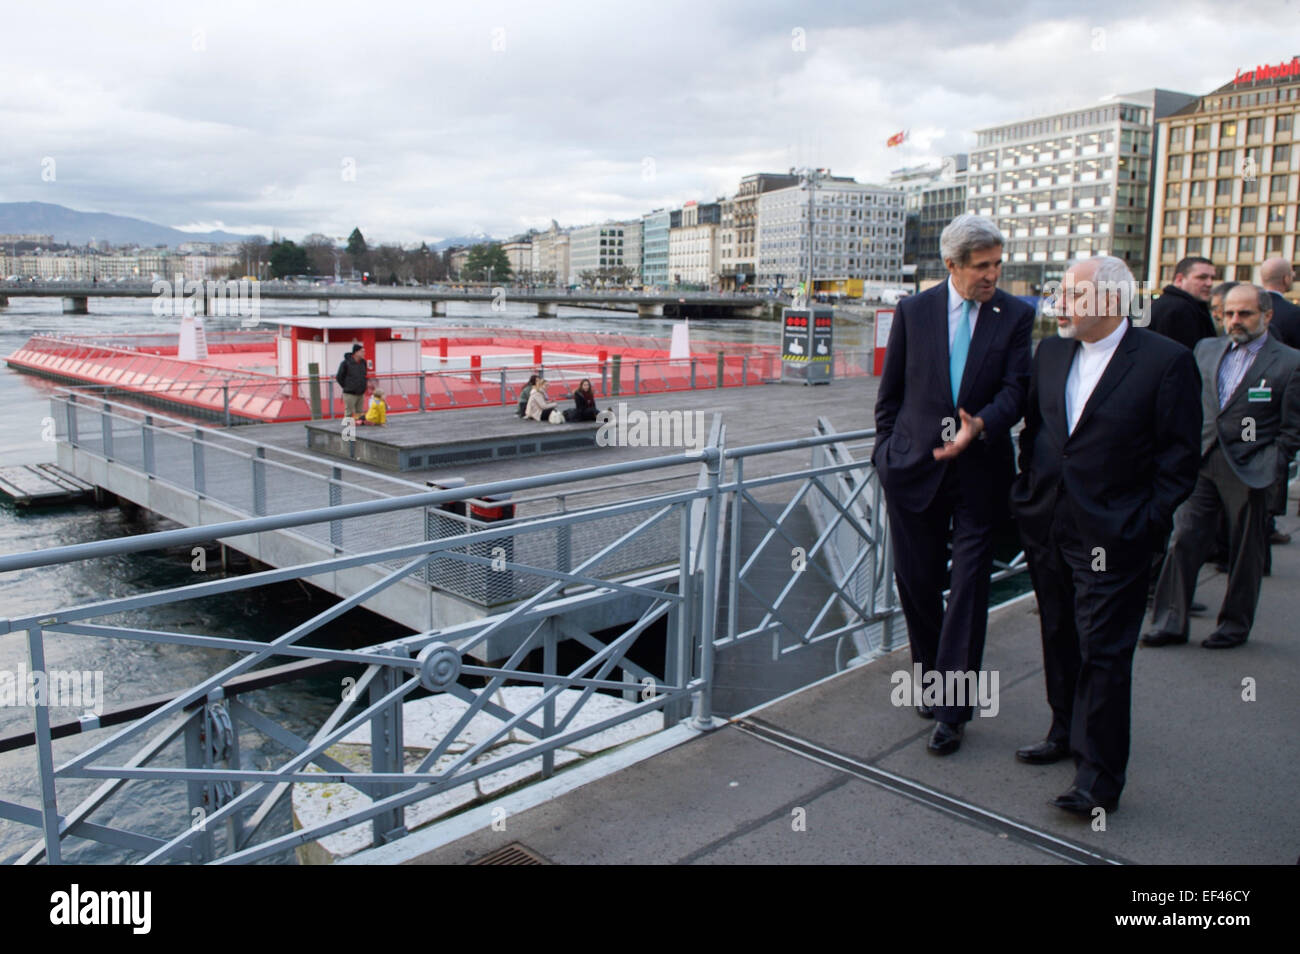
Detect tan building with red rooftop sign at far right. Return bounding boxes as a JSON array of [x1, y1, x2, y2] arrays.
[[1147, 57, 1300, 287]]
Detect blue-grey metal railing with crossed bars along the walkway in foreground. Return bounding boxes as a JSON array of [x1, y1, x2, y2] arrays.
[[0, 402, 1014, 863]]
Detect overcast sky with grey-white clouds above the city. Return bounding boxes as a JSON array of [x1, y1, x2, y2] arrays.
[[0, 0, 1300, 243]]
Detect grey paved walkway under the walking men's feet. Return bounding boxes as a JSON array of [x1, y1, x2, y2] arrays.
[[352, 516, 1300, 864]]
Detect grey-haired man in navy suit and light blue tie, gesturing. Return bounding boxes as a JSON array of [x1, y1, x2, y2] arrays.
[[871, 214, 1034, 755]]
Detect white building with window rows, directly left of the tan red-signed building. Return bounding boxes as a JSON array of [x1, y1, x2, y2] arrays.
[[966, 90, 1193, 294]]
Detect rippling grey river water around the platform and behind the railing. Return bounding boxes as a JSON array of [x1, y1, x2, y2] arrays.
[[0, 298, 870, 863]]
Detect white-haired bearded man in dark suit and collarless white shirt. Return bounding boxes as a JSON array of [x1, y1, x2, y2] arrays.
[[1011, 256, 1213, 818]]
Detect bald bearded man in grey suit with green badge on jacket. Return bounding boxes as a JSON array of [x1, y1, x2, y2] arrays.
[[1141, 283, 1300, 649]]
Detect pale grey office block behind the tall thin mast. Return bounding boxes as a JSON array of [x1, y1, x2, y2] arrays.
[[757, 170, 904, 295]]
